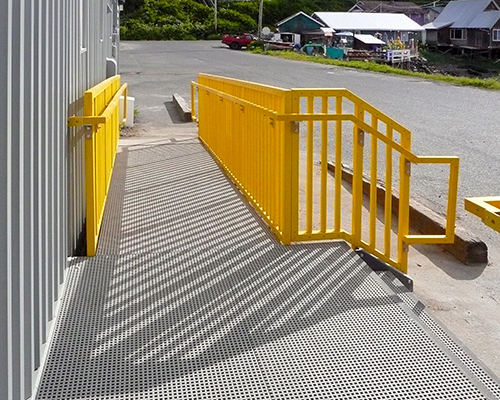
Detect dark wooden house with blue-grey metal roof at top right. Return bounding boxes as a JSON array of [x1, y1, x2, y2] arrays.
[[423, 0, 500, 51]]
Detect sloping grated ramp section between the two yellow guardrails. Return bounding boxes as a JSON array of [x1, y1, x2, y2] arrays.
[[99, 143, 277, 254]]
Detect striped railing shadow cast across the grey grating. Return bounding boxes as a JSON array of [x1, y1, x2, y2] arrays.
[[39, 144, 402, 399]]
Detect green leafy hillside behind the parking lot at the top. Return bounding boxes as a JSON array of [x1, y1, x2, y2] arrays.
[[121, 0, 355, 40]]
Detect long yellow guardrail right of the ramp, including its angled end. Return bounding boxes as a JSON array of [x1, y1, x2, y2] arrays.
[[192, 74, 458, 272]]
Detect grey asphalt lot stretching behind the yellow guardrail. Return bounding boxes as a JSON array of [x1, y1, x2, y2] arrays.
[[120, 41, 500, 260]]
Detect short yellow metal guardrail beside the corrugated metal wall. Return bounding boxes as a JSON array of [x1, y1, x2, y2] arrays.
[[68, 75, 128, 257]]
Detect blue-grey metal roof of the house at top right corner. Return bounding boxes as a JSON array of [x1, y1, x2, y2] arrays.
[[424, 0, 500, 29]]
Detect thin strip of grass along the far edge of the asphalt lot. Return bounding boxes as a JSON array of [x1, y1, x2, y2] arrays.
[[253, 49, 500, 90]]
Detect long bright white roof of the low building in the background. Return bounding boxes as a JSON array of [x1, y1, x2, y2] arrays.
[[313, 12, 424, 32]]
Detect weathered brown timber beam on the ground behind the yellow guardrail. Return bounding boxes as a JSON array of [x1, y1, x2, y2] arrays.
[[328, 163, 488, 264]]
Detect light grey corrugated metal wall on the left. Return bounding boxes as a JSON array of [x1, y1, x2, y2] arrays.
[[0, 0, 117, 400]]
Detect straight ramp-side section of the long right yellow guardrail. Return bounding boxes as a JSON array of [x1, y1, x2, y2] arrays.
[[192, 75, 290, 243]]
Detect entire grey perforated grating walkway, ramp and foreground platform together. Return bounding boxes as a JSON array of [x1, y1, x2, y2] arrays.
[[38, 141, 500, 400]]
